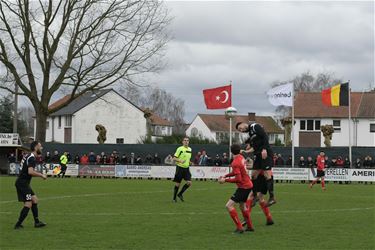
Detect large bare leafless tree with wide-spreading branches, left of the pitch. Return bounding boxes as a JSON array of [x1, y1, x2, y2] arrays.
[[0, 0, 170, 141]]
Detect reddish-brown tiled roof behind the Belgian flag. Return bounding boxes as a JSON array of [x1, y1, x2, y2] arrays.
[[294, 92, 375, 118]]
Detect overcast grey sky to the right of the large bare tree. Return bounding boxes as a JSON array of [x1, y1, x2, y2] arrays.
[[149, 1, 374, 122]]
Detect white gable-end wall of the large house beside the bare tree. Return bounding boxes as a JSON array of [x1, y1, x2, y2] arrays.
[[72, 91, 147, 144]]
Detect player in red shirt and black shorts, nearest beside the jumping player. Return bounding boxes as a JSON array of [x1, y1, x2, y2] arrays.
[[219, 144, 254, 234]]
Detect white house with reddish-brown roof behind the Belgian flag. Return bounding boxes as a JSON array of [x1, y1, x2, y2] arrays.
[[294, 91, 375, 147]]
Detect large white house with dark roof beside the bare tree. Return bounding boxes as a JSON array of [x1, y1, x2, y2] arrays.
[[34, 89, 147, 144]]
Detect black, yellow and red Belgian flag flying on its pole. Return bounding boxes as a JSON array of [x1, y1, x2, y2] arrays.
[[322, 83, 349, 106]]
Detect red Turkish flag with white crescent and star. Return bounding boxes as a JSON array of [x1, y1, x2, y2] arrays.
[[203, 85, 232, 109]]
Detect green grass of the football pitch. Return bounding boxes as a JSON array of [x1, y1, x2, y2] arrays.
[[0, 177, 375, 249]]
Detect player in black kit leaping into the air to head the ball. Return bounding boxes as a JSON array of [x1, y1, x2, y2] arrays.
[[236, 122, 276, 206]]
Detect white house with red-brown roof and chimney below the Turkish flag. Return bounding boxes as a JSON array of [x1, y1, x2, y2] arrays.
[[186, 113, 284, 144]]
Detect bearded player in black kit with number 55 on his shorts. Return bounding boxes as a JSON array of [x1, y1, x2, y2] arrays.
[[14, 141, 47, 229]]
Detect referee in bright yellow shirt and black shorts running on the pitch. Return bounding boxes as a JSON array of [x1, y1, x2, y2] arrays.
[[173, 137, 192, 202]]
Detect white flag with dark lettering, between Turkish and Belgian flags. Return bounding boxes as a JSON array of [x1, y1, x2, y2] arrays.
[[267, 83, 293, 107]]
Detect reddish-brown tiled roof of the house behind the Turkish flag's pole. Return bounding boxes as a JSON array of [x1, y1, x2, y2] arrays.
[[198, 114, 284, 134]]
